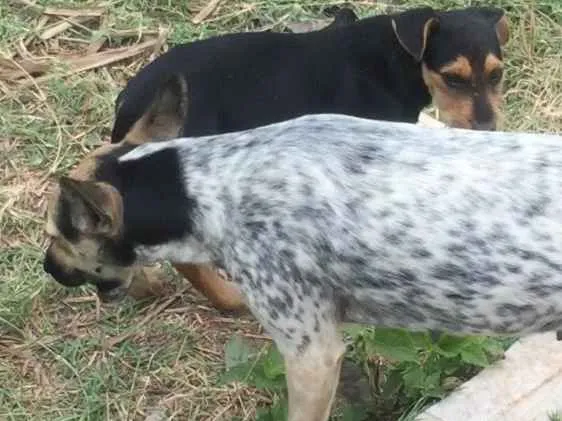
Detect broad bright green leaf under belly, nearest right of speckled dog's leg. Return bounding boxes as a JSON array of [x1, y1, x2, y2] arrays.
[[369, 328, 418, 361]]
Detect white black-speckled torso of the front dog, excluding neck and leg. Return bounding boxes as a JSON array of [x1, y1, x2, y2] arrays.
[[122, 116, 562, 333]]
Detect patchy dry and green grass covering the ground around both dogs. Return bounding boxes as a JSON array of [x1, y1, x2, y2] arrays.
[[0, 0, 562, 421]]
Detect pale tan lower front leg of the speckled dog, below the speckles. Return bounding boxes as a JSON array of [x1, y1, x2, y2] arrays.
[[285, 337, 345, 421]]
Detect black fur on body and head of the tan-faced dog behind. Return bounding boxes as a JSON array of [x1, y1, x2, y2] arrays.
[[111, 8, 501, 143]]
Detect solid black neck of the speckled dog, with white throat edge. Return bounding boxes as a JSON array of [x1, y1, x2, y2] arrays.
[[95, 143, 214, 263]]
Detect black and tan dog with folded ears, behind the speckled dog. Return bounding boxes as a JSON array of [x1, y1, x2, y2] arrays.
[[112, 7, 508, 143]]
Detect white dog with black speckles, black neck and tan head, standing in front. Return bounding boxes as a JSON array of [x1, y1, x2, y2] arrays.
[[44, 115, 562, 421]]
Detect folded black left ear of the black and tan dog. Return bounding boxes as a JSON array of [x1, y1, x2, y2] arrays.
[[392, 7, 439, 61]]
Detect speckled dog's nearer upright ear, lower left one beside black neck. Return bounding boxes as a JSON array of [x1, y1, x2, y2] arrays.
[[59, 177, 123, 236]]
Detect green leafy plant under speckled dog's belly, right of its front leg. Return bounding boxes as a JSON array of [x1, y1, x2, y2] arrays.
[[347, 326, 512, 413]]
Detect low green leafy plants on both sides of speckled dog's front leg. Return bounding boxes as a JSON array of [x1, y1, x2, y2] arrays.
[[220, 326, 512, 421]]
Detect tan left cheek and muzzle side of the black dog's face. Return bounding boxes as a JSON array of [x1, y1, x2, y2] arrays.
[[422, 64, 474, 129]]
